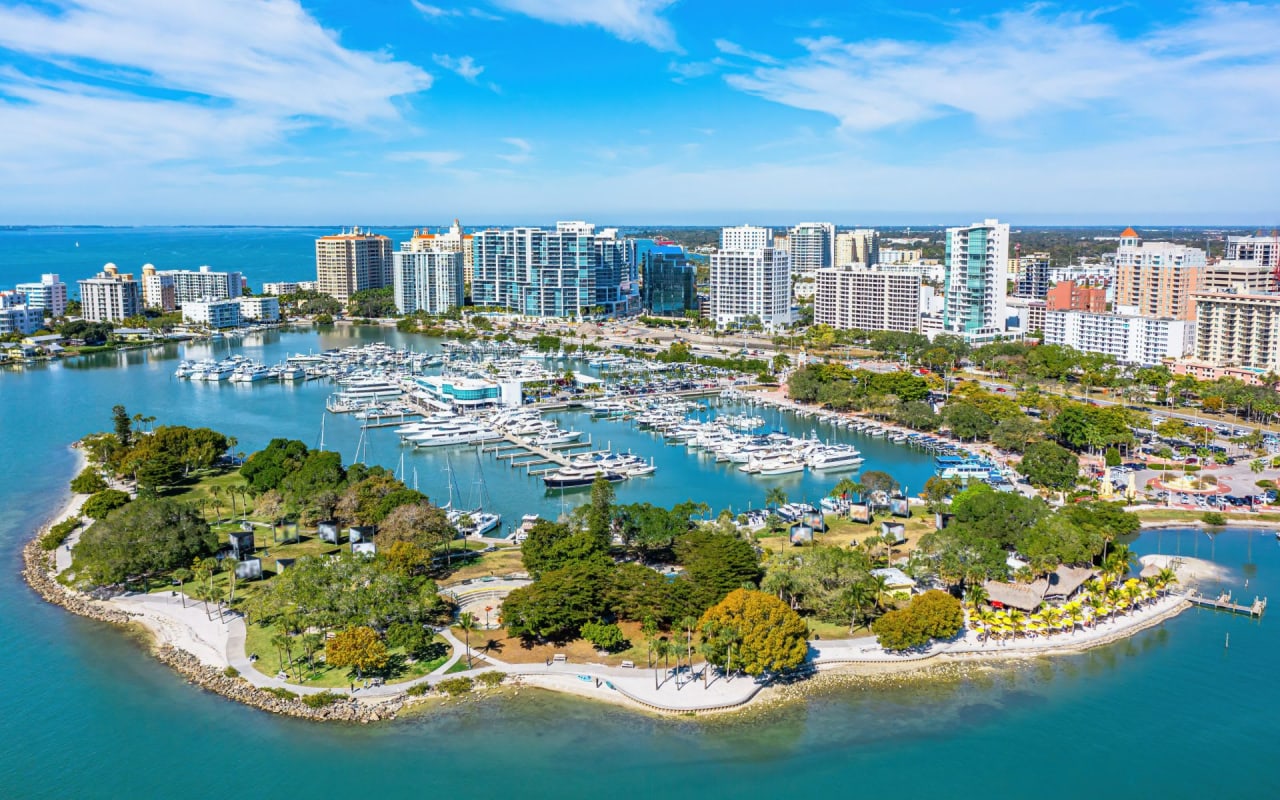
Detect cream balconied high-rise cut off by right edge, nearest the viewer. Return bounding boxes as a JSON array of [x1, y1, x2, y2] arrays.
[[1196, 293, 1280, 372]]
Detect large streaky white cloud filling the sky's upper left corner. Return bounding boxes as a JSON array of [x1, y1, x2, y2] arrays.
[[0, 0, 431, 186]]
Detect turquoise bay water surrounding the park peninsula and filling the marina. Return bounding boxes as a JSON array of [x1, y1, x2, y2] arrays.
[[0, 227, 1280, 800]]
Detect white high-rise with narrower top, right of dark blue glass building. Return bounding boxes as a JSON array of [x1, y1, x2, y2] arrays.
[[709, 225, 791, 329]]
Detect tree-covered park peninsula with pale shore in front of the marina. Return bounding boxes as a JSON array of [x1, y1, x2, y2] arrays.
[[24, 406, 1212, 722]]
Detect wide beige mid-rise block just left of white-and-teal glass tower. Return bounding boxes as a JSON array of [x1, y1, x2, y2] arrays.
[[813, 266, 920, 333]]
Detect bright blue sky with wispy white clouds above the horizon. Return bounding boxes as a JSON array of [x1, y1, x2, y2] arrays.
[[0, 0, 1280, 228]]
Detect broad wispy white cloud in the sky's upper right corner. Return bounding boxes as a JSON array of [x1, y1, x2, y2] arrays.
[[722, 3, 1280, 142]]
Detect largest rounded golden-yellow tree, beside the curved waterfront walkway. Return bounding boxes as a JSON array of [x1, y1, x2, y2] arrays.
[[698, 589, 809, 675]]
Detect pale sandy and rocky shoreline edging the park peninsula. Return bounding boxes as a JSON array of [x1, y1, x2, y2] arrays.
[[22, 451, 1228, 723]]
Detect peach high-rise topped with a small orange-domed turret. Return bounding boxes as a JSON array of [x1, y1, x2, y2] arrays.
[[1115, 228, 1204, 320]]
